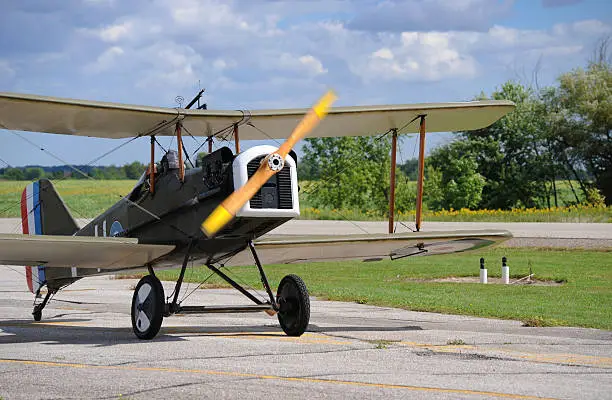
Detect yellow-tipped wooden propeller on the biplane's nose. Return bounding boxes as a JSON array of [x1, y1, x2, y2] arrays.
[[201, 90, 336, 237]]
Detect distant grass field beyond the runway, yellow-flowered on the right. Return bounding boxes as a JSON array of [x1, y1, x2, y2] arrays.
[[0, 180, 612, 222]]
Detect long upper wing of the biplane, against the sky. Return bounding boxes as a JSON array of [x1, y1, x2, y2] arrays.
[[0, 93, 514, 140]]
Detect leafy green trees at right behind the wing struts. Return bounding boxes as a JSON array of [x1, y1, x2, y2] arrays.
[[299, 40, 612, 214]]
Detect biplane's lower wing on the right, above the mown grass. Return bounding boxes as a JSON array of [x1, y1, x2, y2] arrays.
[[220, 230, 512, 266]]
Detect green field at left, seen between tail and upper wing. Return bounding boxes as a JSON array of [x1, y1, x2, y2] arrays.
[[0, 180, 136, 218]]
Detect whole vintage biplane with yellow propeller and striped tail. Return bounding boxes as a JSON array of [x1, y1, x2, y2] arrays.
[[0, 92, 514, 339]]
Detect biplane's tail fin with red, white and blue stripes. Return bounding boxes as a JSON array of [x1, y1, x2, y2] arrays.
[[21, 179, 79, 293]]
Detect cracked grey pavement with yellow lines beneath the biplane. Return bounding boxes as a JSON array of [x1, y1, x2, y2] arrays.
[[0, 221, 612, 400]]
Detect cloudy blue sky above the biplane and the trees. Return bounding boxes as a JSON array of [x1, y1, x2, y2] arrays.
[[0, 0, 612, 167]]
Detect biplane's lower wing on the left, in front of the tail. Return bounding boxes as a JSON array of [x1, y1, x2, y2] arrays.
[[0, 234, 174, 270]]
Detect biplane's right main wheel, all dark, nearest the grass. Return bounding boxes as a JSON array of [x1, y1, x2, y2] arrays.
[[276, 275, 310, 336]]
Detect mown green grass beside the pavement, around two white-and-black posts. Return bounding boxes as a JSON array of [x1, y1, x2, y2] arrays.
[[152, 248, 612, 329]]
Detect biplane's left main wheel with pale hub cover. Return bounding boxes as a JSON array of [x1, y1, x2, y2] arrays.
[[132, 275, 165, 340]]
